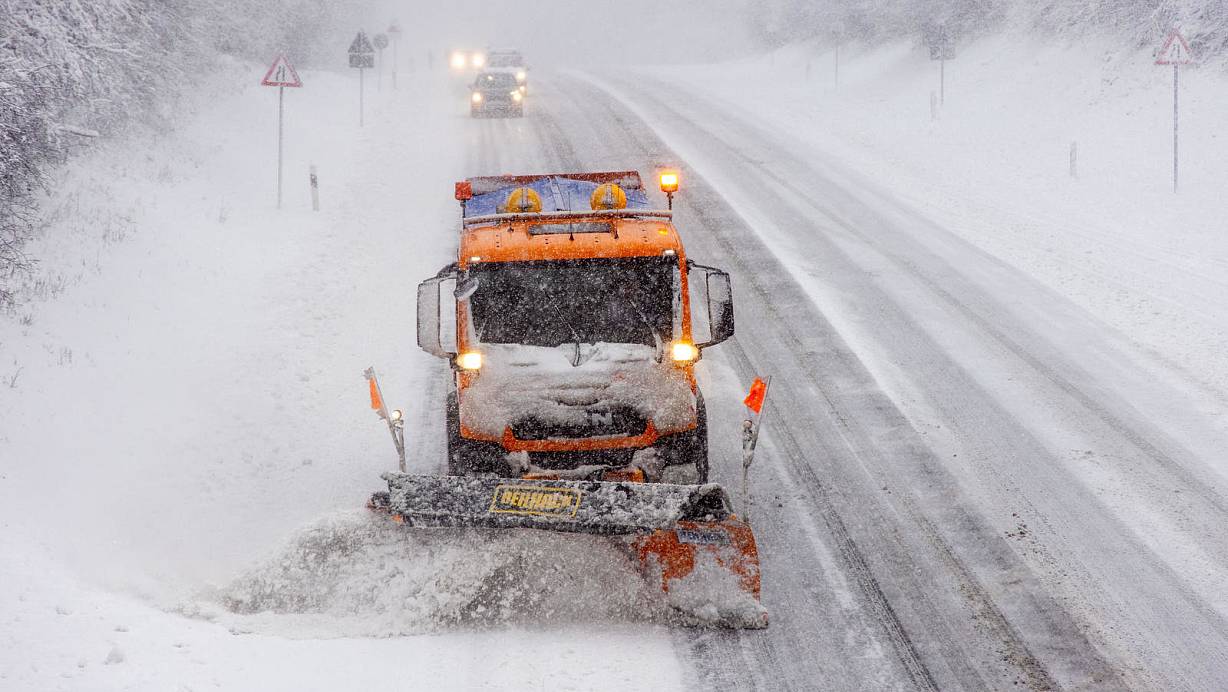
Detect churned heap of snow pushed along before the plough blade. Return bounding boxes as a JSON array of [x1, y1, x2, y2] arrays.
[[213, 512, 679, 637]]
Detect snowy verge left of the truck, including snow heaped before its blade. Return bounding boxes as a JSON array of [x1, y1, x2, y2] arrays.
[[0, 64, 682, 690]]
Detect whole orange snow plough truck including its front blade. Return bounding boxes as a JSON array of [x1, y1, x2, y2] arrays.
[[372, 171, 768, 627]]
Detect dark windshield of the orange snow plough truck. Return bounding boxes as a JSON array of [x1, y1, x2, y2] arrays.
[[469, 258, 678, 346]]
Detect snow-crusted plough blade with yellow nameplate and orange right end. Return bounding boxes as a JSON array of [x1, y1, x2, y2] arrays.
[[368, 472, 768, 628]]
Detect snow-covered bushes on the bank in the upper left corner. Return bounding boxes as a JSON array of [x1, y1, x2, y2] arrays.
[[0, 0, 359, 308]]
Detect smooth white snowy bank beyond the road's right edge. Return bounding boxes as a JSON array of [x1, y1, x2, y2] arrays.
[[652, 36, 1228, 424]]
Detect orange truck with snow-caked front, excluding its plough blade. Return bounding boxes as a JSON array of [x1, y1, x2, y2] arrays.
[[418, 171, 733, 483]]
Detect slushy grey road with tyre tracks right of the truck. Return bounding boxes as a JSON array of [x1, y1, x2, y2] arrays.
[[539, 75, 1228, 690]]
